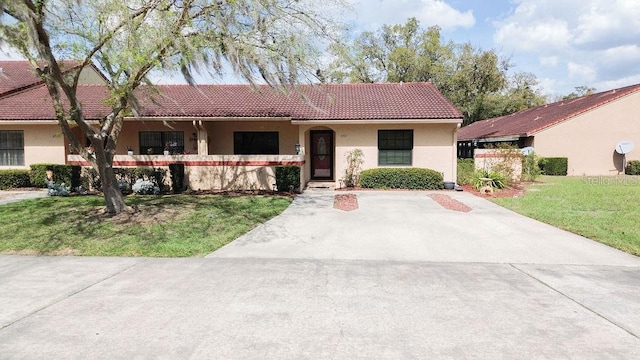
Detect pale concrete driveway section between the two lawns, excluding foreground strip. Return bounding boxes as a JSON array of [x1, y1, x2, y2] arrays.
[[209, 190, 638, 266]]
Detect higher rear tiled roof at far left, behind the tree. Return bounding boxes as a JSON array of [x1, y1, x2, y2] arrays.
[[0, 60, 83, 97]]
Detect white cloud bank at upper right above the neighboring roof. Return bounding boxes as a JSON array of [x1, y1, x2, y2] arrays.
[[493, 0, 640, 90]]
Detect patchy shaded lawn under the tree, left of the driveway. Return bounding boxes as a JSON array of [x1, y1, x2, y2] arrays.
[[0, 195, 291, 257]]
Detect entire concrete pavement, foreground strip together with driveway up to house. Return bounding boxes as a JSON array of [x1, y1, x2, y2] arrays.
[[0, 192, 640, 359]]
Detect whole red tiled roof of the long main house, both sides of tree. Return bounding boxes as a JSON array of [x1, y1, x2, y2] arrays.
[[0, 82, 462, 121]]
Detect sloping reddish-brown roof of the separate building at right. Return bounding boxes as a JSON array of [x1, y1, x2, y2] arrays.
[[458, 84, 640, 140]]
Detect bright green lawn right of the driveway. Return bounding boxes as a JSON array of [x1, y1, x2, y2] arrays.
[[494, 176, 640, 256]]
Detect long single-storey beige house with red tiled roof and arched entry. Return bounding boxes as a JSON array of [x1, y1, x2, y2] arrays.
[[0, 61, 462, 189]]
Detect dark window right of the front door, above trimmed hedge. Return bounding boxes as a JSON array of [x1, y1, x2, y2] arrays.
[[378, 130, 413, 165]]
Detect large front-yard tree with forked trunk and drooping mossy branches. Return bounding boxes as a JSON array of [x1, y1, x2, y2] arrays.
[[0, 0, 341, 214]]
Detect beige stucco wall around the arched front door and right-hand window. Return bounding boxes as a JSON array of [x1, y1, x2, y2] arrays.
[[300, 124, 457, 186]]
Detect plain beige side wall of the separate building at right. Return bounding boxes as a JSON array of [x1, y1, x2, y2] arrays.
[[533, 93, 640, 176]]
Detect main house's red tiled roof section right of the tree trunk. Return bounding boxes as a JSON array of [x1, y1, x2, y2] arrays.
[[136, 83, 462, 120]]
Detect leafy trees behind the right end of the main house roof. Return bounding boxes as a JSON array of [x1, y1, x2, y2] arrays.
[[326, 18, 545, 125]]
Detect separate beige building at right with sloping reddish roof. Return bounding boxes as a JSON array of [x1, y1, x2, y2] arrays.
[[458, 84, 640, 176]]
